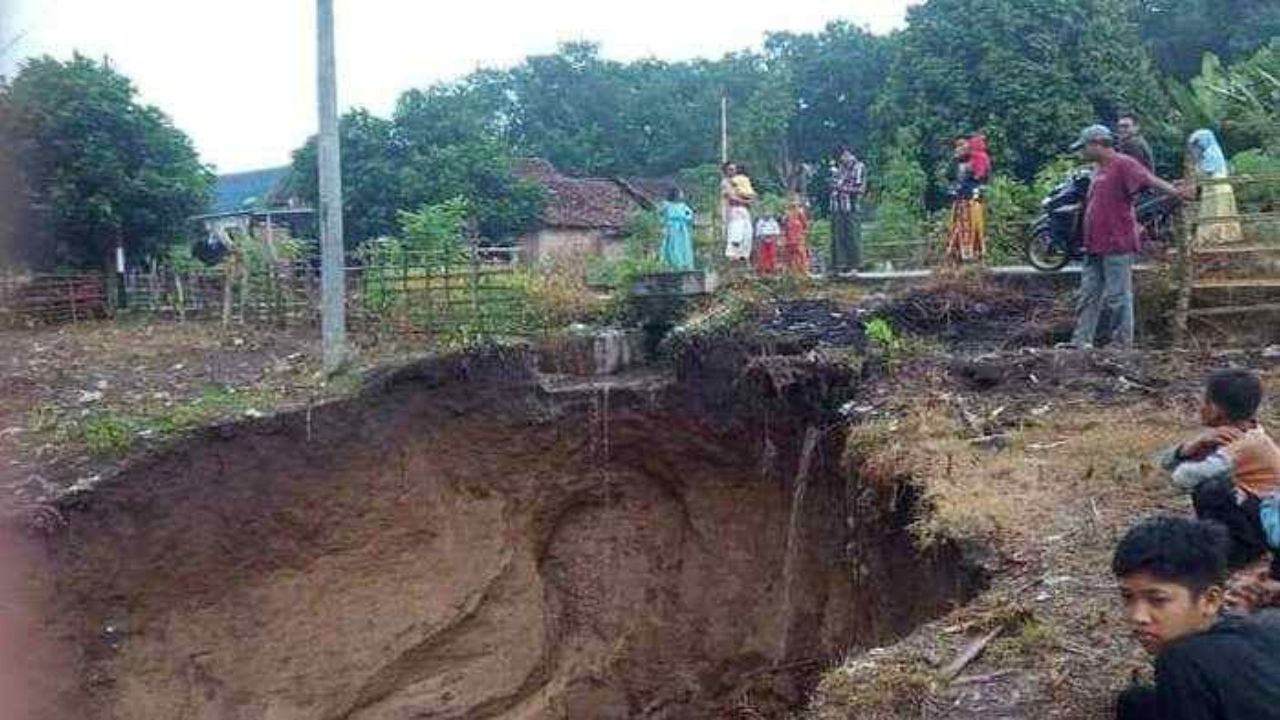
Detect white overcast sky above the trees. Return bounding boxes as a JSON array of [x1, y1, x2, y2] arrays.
[[0, 0, 914, 172]]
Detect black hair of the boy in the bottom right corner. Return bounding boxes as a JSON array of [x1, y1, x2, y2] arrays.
[[1111, 515, 1228, 596]]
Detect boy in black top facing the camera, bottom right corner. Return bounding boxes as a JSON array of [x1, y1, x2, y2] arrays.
[[1111, 516, 1280, 720]]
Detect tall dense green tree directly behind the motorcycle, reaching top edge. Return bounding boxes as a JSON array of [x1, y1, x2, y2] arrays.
[[873, 0, 1169, 194]]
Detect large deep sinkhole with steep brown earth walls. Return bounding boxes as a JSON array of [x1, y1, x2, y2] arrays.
[[20, 345, 978, 720]]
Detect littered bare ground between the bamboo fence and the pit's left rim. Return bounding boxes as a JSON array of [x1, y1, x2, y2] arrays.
[[0, 322, 421, 510]]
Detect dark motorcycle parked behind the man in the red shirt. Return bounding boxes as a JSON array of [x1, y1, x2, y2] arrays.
[[1025, 170, 1181, 273]]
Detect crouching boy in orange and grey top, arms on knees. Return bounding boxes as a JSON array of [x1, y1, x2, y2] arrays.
[[1158, 369, 1280, 577]]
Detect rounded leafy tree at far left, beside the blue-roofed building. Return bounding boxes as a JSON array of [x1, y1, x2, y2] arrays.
[[0, 55, 212, 266]]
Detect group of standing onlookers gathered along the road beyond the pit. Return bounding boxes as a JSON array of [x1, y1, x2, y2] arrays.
[[662, 114, 1240, 316]]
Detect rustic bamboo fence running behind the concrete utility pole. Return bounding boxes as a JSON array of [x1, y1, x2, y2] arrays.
[[0, 246, 534, 337]]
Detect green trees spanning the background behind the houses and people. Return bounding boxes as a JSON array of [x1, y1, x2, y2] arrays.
[[0, 0, 1280, 271]]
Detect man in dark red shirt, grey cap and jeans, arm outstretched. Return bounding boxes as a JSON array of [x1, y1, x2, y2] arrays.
[[1071, 126, 1189, 348]]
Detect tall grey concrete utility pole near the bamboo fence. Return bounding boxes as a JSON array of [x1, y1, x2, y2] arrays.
[[316, 0, 347, 372]]
